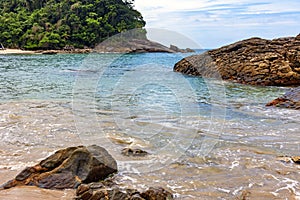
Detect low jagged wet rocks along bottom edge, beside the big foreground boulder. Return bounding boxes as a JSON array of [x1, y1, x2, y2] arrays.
[[75, 180, 173, 200]]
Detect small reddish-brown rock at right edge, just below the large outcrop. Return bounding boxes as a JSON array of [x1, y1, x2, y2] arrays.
[[266, 87, 300, 110]]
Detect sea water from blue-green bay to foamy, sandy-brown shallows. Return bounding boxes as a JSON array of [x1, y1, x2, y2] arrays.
[[0, 50, 300, 200]]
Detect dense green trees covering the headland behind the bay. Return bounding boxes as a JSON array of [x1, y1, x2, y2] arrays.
[[0, 0, 145, 49]]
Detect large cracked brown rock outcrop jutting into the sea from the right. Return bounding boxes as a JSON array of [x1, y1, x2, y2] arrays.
[[174, 34, 300, 86]]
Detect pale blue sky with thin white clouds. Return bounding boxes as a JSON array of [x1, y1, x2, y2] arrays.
[[134, 0, 300, 49]]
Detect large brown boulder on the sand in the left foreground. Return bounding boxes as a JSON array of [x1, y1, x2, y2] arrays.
[[0, 145, 117, 189]]
